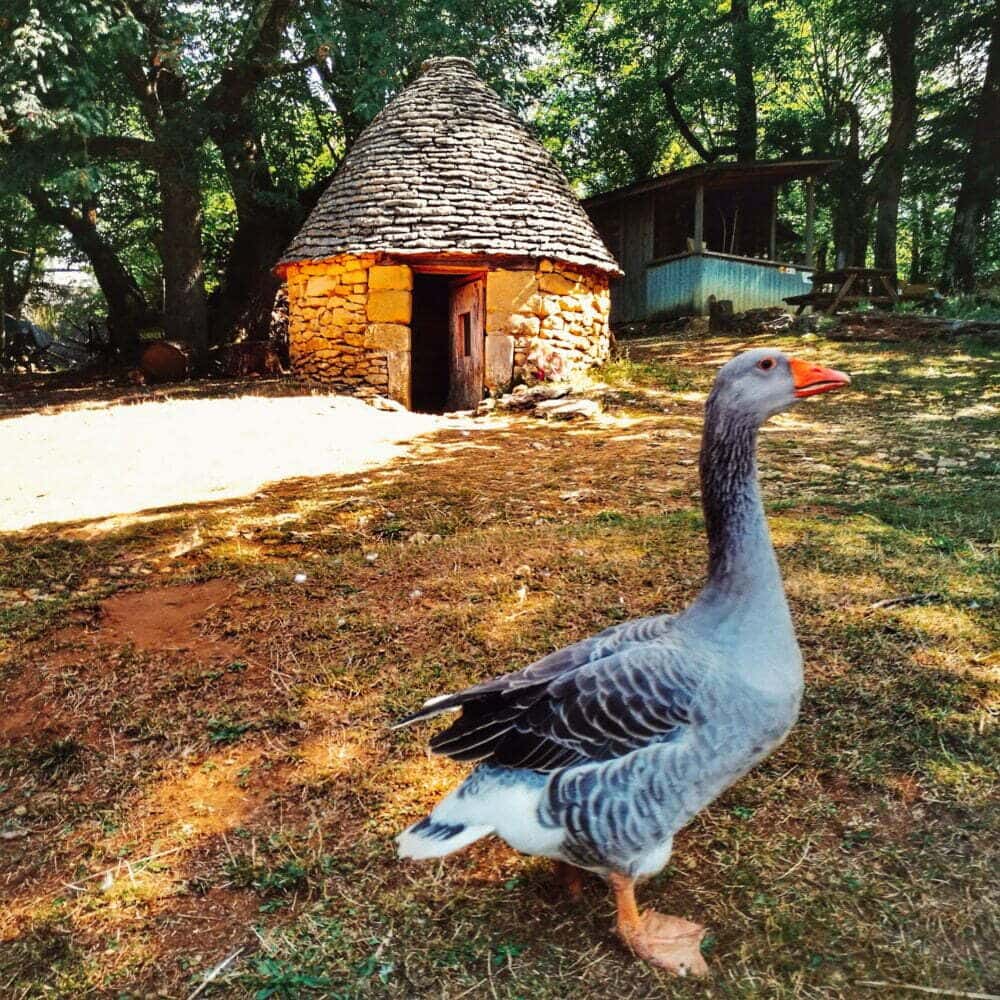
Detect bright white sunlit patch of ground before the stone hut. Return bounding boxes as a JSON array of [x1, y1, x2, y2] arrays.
[[0, 396, 457, 531]]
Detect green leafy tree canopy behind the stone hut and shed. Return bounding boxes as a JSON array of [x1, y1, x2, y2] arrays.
[[0, 0, 1000, 340]]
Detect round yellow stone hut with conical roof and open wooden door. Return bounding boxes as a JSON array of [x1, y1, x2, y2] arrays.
[[278, 57, 620, 412]]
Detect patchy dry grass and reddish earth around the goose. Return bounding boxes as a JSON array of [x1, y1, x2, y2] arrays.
[[0, 338, 1000, 1000]]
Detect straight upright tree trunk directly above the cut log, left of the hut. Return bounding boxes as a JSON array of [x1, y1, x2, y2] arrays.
[[159, 162, 208, 359]]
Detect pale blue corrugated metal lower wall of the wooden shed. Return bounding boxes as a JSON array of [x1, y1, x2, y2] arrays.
[[646, 254, 812, 317]]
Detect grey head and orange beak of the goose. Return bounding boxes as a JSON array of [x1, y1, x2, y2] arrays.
[[709, 347, 851, 426]]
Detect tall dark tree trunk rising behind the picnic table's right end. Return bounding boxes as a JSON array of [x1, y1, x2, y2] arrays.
[[872, 0, 919, 274]]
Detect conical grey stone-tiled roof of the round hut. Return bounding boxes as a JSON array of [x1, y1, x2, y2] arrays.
[[281, 57, 620, 274]]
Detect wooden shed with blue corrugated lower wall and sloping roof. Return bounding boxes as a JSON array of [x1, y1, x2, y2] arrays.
[[583, 159, 837, 323]]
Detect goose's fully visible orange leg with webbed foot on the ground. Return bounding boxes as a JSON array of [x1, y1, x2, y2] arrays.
[[608, 873, 708, 976]]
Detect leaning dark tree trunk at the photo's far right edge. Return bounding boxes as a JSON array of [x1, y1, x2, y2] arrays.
[[942, 13, 1000, 292]]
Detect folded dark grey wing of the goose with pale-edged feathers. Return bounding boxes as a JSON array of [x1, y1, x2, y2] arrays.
[[390, 616, 702, 771]]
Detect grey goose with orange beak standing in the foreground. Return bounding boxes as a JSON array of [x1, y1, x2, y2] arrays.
[[396, 348, 850, 975]]
